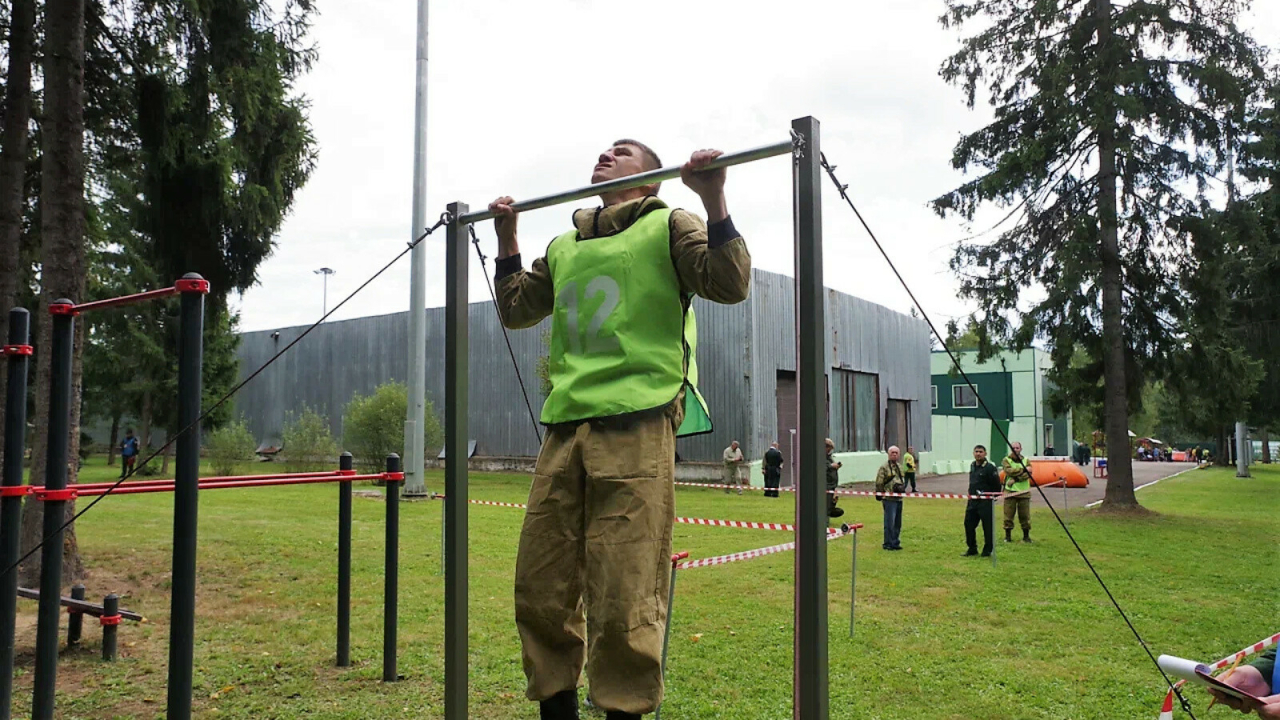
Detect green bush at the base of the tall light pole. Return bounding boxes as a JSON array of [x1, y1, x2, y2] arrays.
[[342, 383, 444, 473]]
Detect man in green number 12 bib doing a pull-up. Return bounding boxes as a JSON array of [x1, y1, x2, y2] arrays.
[[489, 140, 751, 720]]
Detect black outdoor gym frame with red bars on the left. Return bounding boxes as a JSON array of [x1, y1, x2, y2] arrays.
[[0, 273, 404, 720]]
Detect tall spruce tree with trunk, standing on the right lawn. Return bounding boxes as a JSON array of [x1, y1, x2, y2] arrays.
[[932, 0, 1261, 507]]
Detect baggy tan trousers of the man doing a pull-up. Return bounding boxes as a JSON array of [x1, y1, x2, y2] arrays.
[[516, 402, 684, 715]]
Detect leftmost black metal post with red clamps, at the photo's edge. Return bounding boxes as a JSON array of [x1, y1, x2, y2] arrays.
[[0, 307, 31, 720]]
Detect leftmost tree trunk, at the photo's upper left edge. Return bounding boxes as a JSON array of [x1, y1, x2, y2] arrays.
[[0, 0, 36, 458]]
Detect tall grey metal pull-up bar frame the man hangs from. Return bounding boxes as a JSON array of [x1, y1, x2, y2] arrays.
[[444, 118, 828, 720]]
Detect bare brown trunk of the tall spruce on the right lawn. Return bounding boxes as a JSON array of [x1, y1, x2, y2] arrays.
[[1094, 0, 1138, 507]]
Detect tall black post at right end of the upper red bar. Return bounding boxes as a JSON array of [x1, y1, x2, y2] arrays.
[[168, 273, 209, 720]]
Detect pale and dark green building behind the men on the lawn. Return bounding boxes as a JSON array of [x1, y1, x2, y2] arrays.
[[931, 350, 1071, 473]]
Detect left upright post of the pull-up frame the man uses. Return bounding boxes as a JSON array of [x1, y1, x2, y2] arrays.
[[444, 202, 470, 720]]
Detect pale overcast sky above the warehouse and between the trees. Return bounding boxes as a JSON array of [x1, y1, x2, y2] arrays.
[[232, 0, 1280, 329]]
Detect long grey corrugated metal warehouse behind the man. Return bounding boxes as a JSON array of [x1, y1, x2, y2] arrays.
[[236, 270, 932, 466]]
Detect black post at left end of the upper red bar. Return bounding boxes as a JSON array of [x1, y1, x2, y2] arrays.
[[31, 300, 76, 720]]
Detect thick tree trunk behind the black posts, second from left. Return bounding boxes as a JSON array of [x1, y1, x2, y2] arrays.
[[20, 0, 84, 583]]
